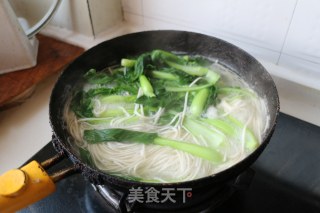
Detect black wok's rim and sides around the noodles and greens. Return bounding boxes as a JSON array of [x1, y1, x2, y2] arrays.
[[0, 30, 279, 211]]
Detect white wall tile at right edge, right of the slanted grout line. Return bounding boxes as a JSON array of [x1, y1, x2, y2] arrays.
[[279, 0, 320, 73]]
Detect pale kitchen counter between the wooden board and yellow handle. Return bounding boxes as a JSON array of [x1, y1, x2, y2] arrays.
[[0, 74, 57, 174]]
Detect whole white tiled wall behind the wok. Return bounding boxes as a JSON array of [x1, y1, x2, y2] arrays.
[[45, 0, 320, 85]]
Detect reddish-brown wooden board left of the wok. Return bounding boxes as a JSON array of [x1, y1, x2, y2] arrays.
[[0, 35, 84, 109]]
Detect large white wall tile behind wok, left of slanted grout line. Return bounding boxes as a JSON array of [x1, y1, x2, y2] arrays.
[[143, 0, 296, 50]]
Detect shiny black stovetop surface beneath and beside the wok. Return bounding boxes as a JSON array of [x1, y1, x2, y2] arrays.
[[20, 113, 320, 213]]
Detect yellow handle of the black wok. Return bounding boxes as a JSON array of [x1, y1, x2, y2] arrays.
[[0, 161, 56, 213]]
